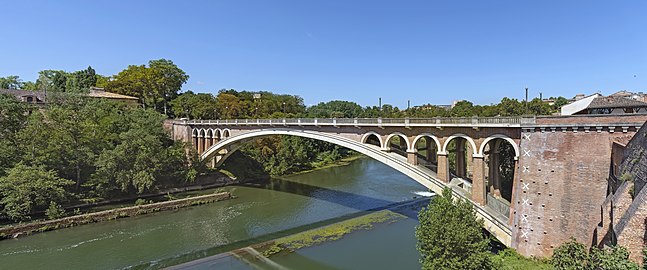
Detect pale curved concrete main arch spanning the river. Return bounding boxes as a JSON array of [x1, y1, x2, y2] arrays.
[[200, 128, 512, 246]]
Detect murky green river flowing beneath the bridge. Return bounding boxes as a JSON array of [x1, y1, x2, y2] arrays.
[[0, 158, 436, 269]]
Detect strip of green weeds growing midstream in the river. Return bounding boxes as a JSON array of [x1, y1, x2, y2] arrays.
[[255, 210, 406, 257]]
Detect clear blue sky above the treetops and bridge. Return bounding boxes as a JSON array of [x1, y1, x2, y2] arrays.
[[0, 0, 647, 107]]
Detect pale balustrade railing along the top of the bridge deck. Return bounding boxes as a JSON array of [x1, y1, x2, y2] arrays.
[[187, 116, 536, 127]]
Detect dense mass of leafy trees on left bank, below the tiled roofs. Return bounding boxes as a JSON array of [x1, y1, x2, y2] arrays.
[[0, 94, 201, 221]]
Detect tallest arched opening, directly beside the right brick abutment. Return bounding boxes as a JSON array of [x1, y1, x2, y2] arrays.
[[483, 138, 516, 203]]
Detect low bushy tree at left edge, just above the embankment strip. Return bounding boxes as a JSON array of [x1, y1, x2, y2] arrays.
[[0, 163, 73, 221]]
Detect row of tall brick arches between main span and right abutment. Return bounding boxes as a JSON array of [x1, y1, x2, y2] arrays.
[[362, 132, 519, 216]]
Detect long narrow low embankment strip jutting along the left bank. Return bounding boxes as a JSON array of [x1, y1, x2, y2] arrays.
[[0, 192, 234, 240]]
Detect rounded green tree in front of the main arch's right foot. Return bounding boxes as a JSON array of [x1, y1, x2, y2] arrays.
[[416, 188, 492, 269]]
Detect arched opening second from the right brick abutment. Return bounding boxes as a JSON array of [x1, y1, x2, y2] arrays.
[[445, 136, 475, 182]]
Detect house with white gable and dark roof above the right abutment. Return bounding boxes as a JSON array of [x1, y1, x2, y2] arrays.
[[561, 93, 647, 115]]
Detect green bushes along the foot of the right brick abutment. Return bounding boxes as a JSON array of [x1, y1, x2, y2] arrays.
[[416, 188, 647, 270]]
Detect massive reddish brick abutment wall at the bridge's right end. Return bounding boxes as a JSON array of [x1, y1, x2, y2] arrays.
[[512, 126, 636, 256]]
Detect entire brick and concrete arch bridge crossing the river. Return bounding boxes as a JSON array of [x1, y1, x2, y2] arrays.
[[165, 115, 647, 256]]
